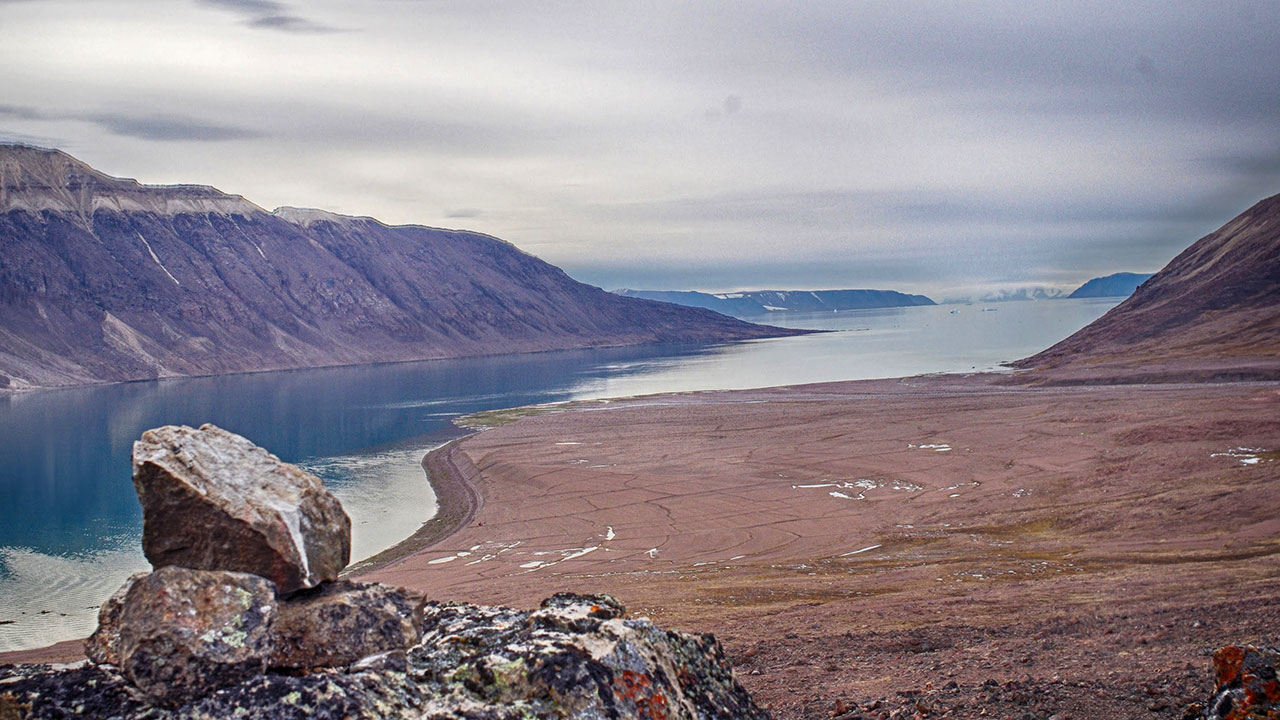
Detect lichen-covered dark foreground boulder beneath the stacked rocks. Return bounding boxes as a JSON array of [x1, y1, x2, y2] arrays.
[[0, 594, 768, 720]]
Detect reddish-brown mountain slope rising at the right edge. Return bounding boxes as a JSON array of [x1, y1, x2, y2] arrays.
[[1012, 195, 1280, 383]]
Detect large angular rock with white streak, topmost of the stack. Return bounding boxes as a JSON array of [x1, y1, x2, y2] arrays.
[[133, 424, 351, 592]]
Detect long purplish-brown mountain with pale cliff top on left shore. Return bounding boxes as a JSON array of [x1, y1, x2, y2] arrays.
[[0, 145, 795, 388]]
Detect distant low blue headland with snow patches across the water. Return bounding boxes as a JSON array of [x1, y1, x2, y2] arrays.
[[613, 290, 934, 318]]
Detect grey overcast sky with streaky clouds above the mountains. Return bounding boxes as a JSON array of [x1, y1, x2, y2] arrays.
[[0, 0, 1280, 297]]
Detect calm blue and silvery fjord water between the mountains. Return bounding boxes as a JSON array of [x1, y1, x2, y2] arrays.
[[0, 299, 1116, 651]]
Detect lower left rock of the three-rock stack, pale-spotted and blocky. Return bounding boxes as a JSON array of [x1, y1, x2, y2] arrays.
[[118, 566, 276, 705]]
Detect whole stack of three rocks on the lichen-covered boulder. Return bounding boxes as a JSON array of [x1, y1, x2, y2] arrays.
[[84, 425, 424, 705]]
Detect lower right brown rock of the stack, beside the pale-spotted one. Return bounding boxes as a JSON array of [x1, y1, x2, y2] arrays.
[[270, 580, 425, 669]]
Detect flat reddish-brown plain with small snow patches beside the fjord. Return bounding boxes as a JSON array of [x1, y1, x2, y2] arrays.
[[361, 375, 1280, 717]]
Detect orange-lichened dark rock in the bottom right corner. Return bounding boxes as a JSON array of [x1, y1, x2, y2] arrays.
[[1206, 644, 1280, 720]]
